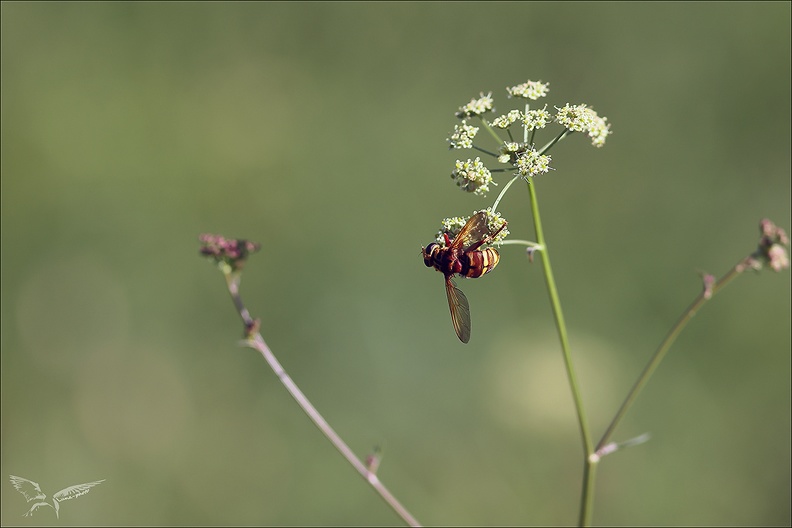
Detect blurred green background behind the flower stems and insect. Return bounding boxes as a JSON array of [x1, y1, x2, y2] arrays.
[[0, 2, 792, 526]]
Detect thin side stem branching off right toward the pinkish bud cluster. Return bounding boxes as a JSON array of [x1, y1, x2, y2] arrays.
[[597, 261, 746, 451]]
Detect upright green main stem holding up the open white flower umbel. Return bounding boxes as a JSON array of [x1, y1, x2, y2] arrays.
[[528, 180, 596, 526]]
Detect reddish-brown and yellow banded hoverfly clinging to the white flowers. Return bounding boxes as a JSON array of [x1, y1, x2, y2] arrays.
[[422, 211, 506, 343]]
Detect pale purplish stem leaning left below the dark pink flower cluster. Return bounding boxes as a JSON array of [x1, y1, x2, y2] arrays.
[[225, 272, 421, 526]]
